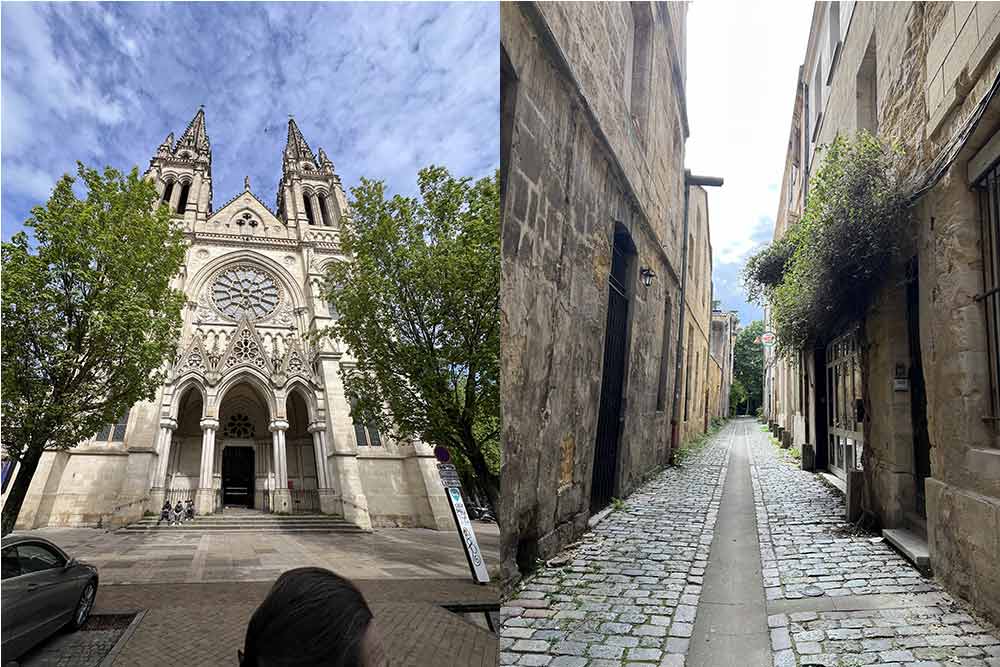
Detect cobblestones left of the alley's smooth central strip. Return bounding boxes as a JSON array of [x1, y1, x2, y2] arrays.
[[500, 425, 734, 667]]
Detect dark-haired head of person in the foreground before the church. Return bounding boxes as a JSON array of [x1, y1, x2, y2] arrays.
[[240, 567, 388, 667]]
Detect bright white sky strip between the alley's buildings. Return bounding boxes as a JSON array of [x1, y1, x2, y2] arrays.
[[686, 0, 813, 320]]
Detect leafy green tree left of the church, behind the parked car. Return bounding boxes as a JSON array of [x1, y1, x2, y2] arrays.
[[0, 163, 186, 534]]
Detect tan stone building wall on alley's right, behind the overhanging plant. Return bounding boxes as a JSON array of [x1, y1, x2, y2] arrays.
[[765, 2, 1000, 619]]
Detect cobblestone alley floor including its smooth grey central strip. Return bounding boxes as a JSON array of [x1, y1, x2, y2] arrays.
[[500, 419, 1000, 667]]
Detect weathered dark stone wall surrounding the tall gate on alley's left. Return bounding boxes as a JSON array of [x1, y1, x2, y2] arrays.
[[499, 2, 687, 578]]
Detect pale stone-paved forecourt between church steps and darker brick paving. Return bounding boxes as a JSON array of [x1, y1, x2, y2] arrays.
[[15, 521, 500, 584]]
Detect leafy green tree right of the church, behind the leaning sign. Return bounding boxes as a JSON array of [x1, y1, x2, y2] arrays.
[[326, 167, 500, 507]]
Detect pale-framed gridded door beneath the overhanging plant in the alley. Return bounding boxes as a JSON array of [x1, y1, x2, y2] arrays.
[[826, 331, 864, 479]]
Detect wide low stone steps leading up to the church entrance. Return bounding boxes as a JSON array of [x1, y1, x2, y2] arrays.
[[120, 507, 366, 535]]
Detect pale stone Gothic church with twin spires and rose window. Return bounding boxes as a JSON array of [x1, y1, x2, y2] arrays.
[[6, 109, 451, 530]]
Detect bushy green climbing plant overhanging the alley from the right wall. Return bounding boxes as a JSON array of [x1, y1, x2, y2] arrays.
[[743, 131, 912, 354]]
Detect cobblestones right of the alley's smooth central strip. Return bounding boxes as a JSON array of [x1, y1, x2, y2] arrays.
[[751, 429, 1000, 667]]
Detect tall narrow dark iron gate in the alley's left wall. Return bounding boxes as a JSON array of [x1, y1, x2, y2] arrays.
[[590, 243, 629, 513]]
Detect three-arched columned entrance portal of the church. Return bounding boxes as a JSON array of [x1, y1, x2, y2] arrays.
[[150, 371, 336, 514]]
